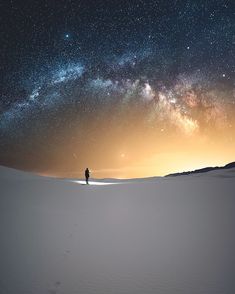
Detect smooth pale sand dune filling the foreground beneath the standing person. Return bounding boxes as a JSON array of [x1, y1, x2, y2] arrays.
[[0, 167, 235, 294]]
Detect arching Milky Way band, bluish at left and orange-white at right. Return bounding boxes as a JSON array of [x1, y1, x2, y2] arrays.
[[0, 53, 235, 136]]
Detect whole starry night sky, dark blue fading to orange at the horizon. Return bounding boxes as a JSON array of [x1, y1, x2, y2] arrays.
[[0, 0, 235, 178]]
